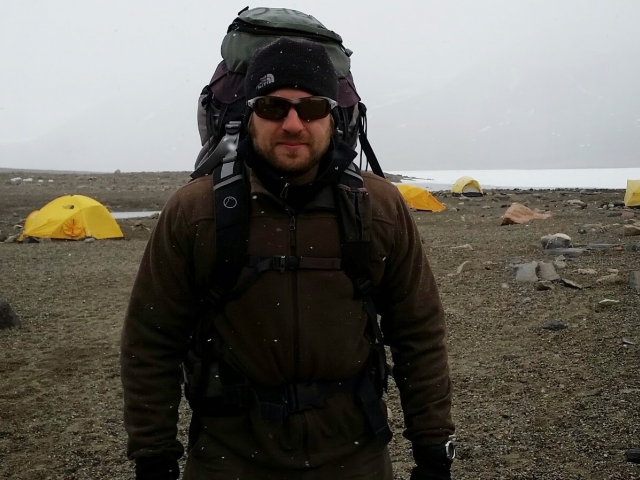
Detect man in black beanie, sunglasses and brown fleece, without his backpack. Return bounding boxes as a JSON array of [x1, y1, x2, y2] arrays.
[[121, 38, 454, 480]]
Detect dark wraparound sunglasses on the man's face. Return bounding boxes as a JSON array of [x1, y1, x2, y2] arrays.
[[247, 97, 338, 122]]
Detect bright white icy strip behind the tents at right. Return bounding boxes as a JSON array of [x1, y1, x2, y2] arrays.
[[389, 168, 640, 191]]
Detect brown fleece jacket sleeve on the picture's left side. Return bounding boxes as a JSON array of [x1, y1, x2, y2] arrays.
[[120, 196, 196, 459]]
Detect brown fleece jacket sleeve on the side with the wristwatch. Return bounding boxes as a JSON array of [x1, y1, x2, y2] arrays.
[[380, 194, 454, 445]]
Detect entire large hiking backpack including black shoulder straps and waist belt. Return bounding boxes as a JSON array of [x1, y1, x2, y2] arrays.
[[183, 8, 392, 445]]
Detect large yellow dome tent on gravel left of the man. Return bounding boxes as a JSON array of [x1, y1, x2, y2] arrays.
[[20, 195, 124, 240]]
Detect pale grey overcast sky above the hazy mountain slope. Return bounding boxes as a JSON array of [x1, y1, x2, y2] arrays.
[[0, 0, 640, 171]]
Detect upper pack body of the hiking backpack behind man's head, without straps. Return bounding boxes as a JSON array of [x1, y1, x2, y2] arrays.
[[191, 7, 384, 179]]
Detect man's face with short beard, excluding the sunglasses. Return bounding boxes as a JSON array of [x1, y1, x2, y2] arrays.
[[249, 88, 333, 176]]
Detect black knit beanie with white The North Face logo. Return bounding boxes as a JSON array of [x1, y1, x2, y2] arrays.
[[244, 37, 338, 100]]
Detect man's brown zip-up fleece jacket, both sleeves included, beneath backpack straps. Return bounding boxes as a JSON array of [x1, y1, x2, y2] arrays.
[[121, 167, 454, 467]]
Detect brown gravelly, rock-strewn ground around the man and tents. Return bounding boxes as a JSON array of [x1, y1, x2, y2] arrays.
[[0, 172, 640, 480]]
